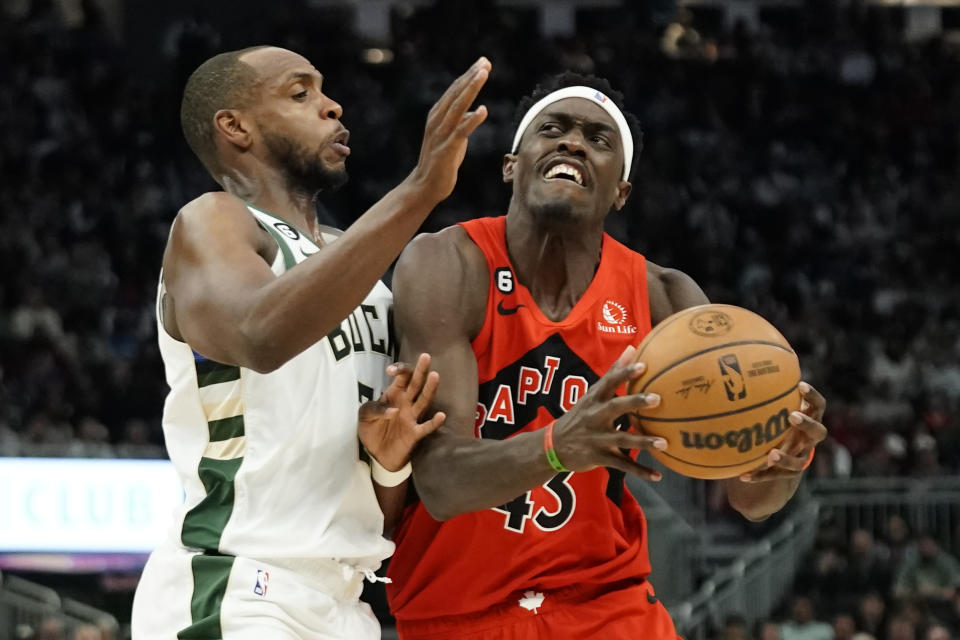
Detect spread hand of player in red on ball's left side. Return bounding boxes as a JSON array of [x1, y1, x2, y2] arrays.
[[554, 347, 667, 480]]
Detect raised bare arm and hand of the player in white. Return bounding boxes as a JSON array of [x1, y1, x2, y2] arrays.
[[164, 58, 490, 371]]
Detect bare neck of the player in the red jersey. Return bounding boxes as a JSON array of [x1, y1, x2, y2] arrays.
[[506, 215, 603, 320]]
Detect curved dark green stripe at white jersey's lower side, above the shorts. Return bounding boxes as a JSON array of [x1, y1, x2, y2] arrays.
[[180, 458, 243, 551]]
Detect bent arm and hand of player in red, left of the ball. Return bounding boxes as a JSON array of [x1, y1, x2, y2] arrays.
[[393, 227, 665, 520]]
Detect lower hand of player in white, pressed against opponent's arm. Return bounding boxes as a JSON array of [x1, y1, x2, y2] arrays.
[[357, 353, 446, 471]]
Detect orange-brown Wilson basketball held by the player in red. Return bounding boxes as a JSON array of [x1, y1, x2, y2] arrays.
[[629, 304, 801, 480]]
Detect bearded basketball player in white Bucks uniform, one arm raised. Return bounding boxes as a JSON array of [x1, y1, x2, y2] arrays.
[[132, 47, 490, 640]]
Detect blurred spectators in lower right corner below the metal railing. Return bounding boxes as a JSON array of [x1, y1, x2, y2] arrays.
[[716, 515, 960, 640]]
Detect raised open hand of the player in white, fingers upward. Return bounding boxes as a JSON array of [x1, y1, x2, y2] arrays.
[[411, 57, 491, 202]]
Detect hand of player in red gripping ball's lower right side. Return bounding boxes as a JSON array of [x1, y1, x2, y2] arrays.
[[740, 382, 827, 482]]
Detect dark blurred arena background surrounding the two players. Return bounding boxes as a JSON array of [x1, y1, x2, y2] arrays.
[[0, 0, 960, 640]]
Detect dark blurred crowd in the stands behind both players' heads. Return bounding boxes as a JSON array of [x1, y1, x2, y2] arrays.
[[0, 0, 960, 476]]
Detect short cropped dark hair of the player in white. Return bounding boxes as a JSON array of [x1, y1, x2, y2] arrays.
[[180, 46, 264, 173]]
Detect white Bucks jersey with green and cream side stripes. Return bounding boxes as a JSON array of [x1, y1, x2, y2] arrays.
[[158, 206, 394, 567]]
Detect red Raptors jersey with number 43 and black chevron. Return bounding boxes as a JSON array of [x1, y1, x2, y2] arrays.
[[387, 217, 650, 621]]
